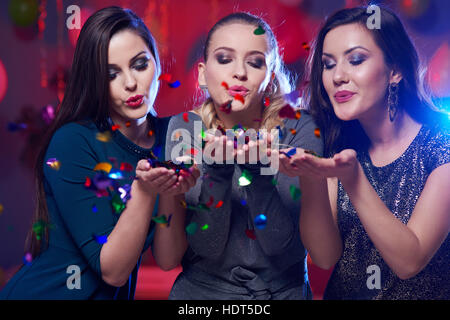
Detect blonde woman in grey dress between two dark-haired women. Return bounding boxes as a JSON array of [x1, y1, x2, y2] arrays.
[[166, 13, 322, 300]]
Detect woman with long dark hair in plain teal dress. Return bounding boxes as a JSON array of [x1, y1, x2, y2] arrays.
[[0, 7, 199, 299]]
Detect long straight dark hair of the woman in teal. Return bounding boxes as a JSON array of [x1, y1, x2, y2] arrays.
[[25, 6, 161, 257]]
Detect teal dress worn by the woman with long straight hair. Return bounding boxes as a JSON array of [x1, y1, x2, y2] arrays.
[[0, 116, 168, 300]]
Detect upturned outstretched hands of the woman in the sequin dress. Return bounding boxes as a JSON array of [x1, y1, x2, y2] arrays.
[[280, 148, 358, 180]]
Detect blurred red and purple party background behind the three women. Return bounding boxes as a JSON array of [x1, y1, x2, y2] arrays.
[[0, 0, 450, 299]]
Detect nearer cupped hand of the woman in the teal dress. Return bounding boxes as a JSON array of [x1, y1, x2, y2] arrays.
[[135, 159, 177, 196]]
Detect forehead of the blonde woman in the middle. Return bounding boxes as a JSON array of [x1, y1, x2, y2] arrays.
[[208, 22, 269, 53]]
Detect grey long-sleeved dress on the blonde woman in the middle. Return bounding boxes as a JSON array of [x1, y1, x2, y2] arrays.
[[166, 112, 323, 300]]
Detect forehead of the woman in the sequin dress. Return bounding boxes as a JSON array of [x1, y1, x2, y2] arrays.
[[323, 23, 381, 55]]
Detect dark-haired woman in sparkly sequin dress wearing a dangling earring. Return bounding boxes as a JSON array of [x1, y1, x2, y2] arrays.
[[280, 8, 450, 299]]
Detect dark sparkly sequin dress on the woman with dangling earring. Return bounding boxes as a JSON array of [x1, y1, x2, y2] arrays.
[[324, 125, 450, 300]]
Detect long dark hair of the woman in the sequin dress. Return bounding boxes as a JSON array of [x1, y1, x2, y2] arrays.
[[304, 7, 437, 156]]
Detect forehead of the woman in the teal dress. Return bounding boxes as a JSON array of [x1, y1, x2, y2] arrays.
[[108, 29, 150, 63]]
